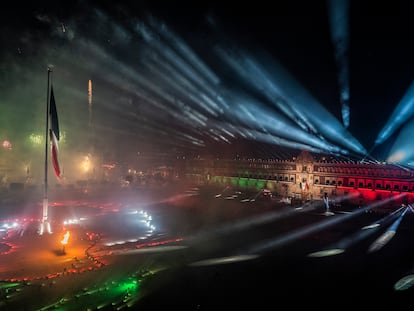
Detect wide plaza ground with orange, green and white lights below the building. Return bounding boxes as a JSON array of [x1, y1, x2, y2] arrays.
[[0, 188, 414, 310]]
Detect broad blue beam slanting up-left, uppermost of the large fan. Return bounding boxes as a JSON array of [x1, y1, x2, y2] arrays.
[[217, 49, 367, 155]]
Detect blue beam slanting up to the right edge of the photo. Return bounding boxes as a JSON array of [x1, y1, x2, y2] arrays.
[[375, 82, 414, 145]]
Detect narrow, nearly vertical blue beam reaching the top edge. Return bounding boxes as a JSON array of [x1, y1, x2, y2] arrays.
[[328, 0, 350, 128]]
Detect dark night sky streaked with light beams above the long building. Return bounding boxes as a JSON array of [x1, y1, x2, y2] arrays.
[[0, 1, 414, 167]]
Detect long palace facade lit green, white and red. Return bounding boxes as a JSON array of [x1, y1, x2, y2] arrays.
[[186, 151, 414, 204]]
